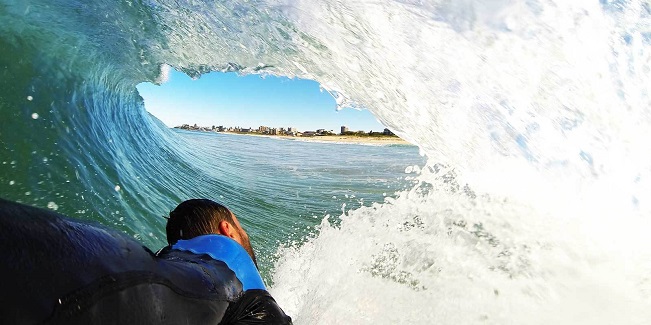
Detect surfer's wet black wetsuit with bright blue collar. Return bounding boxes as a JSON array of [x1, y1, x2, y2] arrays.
[[0, 199, 291, 324]]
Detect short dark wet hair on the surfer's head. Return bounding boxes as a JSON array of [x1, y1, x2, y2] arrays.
[[165, 199, 235, 245]]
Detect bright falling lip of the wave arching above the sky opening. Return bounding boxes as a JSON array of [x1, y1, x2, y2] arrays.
[[152, 0, 651, 205]]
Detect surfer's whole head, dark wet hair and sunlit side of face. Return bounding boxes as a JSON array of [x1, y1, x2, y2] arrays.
[[165, 199, 258, 266]]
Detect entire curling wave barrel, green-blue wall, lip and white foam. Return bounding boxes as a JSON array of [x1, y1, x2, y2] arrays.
[[0, 0, 651, 324]]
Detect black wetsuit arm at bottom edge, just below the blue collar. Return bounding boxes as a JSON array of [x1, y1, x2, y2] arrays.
[[220, 289, 292, 325]]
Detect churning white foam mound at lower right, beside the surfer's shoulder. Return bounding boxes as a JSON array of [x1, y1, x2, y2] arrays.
[[272, 161, 651, 324]]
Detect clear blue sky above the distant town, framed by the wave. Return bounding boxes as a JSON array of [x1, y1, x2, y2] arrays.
[[138, 70, 384, 133]]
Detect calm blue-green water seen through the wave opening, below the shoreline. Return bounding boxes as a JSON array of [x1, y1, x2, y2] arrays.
[[168, 130, 426, 271]]
